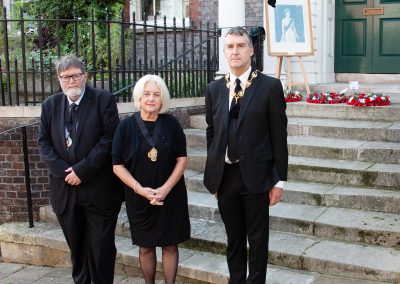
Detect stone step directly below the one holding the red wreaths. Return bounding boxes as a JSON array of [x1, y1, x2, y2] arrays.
[[186, 114, 400, 141]]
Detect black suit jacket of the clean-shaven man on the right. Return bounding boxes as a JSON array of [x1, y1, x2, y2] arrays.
[[204, 74, 288, 193]]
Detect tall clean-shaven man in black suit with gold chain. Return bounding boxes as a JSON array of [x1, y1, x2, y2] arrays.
[[204, 27, 288, 284]]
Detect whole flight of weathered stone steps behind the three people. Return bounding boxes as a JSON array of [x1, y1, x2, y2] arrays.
[[0, 99, 400, 284]]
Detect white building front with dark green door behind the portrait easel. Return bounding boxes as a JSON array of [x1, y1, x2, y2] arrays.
[[206, 0, 400, 84]]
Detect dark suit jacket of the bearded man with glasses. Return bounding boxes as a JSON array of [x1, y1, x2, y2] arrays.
[[38, 86, 123, 214]]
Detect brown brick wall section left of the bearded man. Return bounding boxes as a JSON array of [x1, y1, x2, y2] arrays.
[[0, 119, 49, 224]]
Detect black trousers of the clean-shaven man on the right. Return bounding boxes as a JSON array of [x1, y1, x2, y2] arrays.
[[218, 163, 269, 284]]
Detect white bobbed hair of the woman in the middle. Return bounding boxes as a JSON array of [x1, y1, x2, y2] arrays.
[[133, 75, 170, 113]]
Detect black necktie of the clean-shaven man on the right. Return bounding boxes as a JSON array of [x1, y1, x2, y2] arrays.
[[228, 78, 242, 163]]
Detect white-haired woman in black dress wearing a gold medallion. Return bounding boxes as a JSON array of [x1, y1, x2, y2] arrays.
[[112, 75, 190, 284]]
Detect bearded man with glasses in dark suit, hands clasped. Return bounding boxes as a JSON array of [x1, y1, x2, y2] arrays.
[[38, 55, 123, 284]]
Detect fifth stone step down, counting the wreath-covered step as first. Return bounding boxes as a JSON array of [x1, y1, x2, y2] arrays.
[[185, 170, 400, 214]]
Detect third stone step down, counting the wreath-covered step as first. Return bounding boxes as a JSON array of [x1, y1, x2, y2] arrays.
[[185, 129, 400, 164]]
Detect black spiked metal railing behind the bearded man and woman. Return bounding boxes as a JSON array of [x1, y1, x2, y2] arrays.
[[0, 8, 218, 106]]
